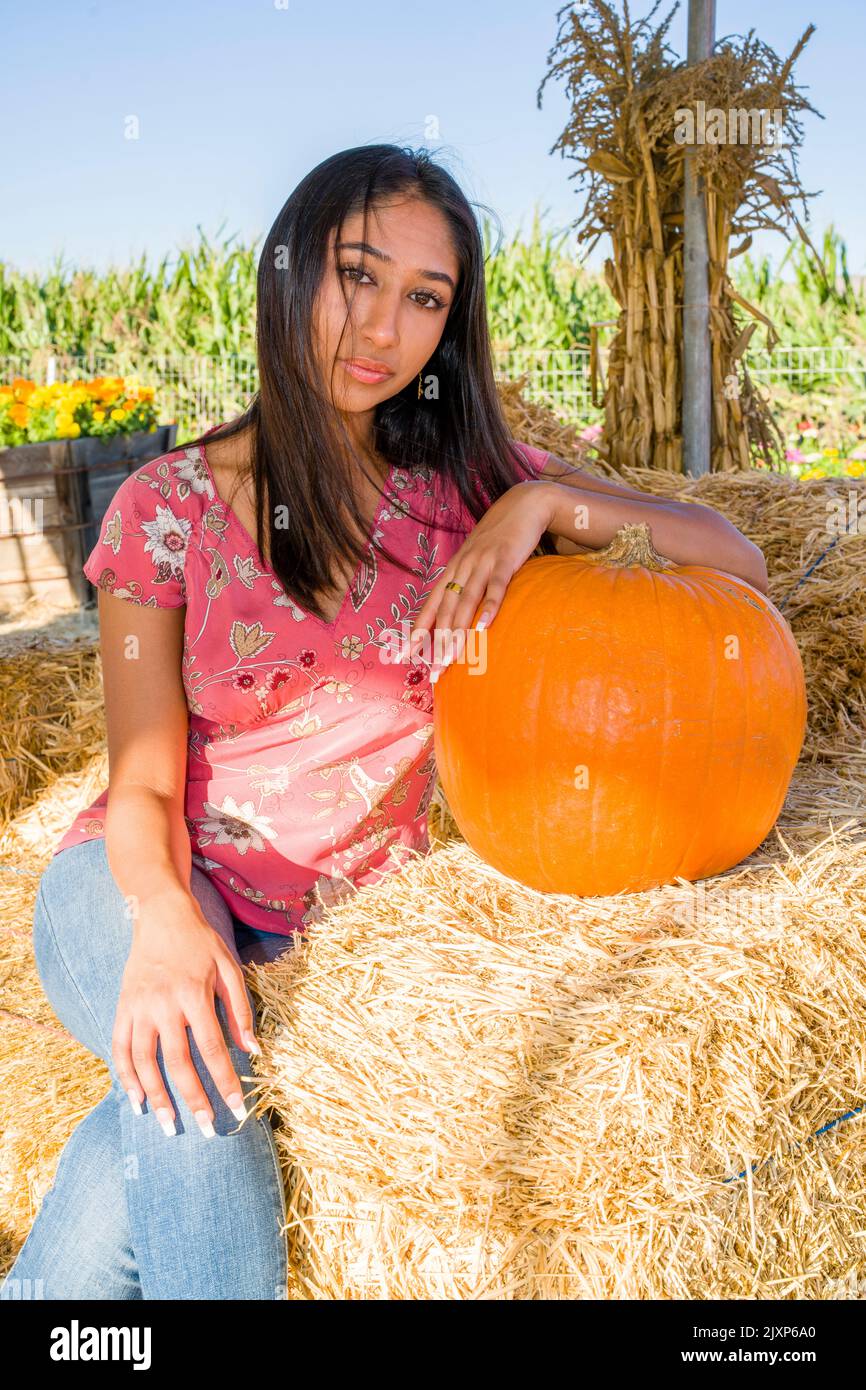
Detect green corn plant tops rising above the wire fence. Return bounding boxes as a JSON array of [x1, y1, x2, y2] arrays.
[[0, 210, 866, 361]]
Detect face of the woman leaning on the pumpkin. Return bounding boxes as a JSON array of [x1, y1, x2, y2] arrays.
[[314, 197, 460, 414]]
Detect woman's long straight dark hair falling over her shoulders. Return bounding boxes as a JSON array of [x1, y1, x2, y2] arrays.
[[179, 145, 555, 620]]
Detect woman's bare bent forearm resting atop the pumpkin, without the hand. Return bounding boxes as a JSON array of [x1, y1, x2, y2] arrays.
[[530, 455, 767, 594]]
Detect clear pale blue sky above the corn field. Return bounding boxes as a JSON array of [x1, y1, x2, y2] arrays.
[[0, 0, 866, 274]]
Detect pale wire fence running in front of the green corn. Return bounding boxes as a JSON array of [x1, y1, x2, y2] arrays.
[[0, 346, 866, 439]]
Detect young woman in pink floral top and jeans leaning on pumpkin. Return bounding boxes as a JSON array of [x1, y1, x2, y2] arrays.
[[3, 145, 766, 1298]]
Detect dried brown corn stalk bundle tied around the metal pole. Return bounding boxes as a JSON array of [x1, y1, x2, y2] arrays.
[[539, 0, 820, 473]]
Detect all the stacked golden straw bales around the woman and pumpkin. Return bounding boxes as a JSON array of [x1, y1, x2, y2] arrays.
[[0, 405, 866, 1298]]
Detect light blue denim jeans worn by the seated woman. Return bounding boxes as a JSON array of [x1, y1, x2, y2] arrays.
[[0, 840, 292, 1300]]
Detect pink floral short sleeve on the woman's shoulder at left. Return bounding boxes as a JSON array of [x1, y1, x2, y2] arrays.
[[82, 468, 192, 607]]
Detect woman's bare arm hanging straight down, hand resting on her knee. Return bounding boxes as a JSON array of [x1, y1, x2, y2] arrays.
[[99, 589, 254, 1137]]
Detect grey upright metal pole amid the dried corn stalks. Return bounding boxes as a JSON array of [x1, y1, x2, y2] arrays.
[[683, 0, 716, 477]]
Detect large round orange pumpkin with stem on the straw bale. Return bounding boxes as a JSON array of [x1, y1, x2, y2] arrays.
[[434, 524, 806, 897]]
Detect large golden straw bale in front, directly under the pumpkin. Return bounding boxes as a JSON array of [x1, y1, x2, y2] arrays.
[[250, 765, 866, 1298]]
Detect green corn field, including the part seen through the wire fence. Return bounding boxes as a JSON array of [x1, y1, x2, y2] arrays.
[[0, 209, 866, 450]]
